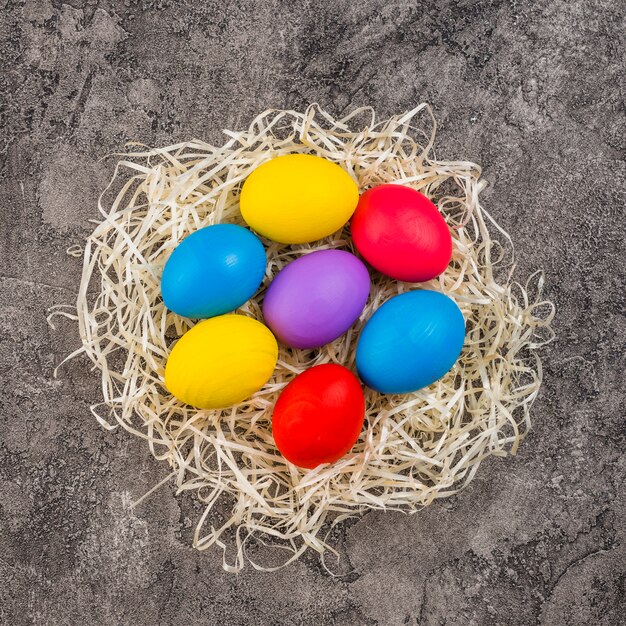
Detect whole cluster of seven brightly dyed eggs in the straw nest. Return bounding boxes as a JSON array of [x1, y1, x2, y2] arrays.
[[161, 154, 465, 468]]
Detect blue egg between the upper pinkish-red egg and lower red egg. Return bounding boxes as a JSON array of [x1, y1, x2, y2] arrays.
[[356, 290, 465, 393]]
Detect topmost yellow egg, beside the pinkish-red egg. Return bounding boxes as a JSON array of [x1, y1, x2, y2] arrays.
[[240, 154, 359, 243]]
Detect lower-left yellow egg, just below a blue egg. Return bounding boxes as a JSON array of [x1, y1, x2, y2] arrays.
[[165, 315, 278, 409]]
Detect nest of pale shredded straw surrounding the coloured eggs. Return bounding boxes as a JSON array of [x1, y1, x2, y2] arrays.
[[51, 104, 554, 571]]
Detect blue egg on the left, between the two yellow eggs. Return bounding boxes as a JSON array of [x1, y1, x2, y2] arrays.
[[161, 224, 266, 319]]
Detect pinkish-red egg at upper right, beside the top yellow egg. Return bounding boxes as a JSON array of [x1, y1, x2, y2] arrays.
[[350, 185, 452, 283]]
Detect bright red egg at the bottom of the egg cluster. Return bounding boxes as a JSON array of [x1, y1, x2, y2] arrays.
[[272, 363, 365, 469]]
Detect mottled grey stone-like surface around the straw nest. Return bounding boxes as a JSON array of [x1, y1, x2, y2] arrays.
[[0, 0, 626, 626]]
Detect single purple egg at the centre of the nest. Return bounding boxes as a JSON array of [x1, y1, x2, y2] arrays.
[[263, 250, 370, 348]]
